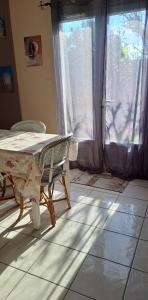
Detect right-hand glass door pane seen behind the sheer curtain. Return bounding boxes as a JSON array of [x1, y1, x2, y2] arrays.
[[106, 10, 145, 144]]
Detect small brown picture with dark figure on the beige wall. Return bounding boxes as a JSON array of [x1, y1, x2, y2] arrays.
[[24, 35, 43, 67]]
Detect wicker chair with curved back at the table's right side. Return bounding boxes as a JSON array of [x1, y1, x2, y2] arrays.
[[39, 135, 71, 226]]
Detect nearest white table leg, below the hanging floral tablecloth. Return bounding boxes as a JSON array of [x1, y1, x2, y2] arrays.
[[31, 199, 40, 229]]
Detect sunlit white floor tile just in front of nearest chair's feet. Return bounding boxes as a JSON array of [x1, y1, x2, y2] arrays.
[[34, 219, 94, 252]]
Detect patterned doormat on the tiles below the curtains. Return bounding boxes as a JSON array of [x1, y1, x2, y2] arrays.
[[70, 169, 128, 193]]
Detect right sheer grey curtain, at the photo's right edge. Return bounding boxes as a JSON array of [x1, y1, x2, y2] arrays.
[[104, 1, 148, 177]]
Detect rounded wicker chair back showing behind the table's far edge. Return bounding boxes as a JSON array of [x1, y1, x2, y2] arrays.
[[11, 120, 46, 133]]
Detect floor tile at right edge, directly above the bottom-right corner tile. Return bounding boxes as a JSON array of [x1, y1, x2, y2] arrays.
[[133, 240, 148, 272]]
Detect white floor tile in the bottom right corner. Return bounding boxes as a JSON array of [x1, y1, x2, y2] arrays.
[[124, 270, 148, 300]]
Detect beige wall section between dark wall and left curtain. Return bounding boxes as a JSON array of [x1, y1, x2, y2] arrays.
[[9, 0, 57, 133]]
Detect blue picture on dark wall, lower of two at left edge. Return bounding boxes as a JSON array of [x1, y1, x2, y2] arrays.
[[0, 66, 14, 93]]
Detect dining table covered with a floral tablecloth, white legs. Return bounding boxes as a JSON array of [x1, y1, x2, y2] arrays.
[[0, 129, 70, 229]]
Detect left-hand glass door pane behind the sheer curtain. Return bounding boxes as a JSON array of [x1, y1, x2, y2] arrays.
[[60, 19, 94, 140]]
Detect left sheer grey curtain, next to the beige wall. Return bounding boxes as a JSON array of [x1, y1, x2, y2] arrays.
[[52, 0, 107, 173]]
